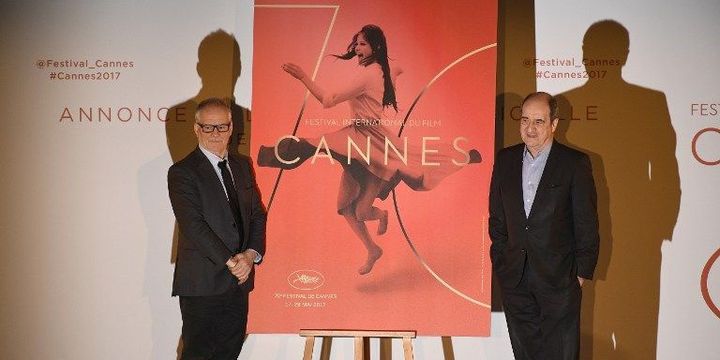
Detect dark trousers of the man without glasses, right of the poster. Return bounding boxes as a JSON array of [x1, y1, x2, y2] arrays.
[[502, 266, 582, 360]]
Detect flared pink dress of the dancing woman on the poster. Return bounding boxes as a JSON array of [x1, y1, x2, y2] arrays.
[[305, 63, 466, 210]]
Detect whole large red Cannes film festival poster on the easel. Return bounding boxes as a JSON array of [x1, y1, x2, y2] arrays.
[[250, 1, 497, 336]]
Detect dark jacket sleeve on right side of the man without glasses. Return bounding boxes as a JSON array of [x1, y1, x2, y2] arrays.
[[571, 154, 600, 279]]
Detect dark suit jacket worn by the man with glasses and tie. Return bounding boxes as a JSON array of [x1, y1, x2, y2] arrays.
[[168, 148, 267, 296]]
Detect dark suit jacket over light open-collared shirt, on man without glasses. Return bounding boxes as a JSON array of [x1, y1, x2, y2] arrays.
[[489, 141, 600, 288]]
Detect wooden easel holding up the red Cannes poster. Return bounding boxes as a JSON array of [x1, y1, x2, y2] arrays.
[[300, 330, 415, 360]]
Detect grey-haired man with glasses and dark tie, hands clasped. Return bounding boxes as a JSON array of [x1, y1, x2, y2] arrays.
[[168, 98, 267, 359]]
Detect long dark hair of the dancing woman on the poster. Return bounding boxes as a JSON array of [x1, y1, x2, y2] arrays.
[[333, 25, 397, 111]]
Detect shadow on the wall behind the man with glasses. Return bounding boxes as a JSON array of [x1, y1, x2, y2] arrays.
[[160, 30, 250, 356]]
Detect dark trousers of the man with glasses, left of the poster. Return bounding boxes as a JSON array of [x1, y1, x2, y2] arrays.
[[180, 286, 248, 360]]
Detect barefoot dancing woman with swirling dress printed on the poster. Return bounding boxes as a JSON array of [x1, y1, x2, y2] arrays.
[[258, 25, 480, 275]]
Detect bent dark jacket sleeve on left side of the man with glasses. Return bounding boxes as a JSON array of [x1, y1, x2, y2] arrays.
[[168, 165, 232, 265]]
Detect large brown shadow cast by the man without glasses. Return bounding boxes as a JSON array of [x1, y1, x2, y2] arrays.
[[556, 20, 680, 360]]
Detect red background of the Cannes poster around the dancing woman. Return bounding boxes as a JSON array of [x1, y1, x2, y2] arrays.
[[249, 0, 497, 336]]
